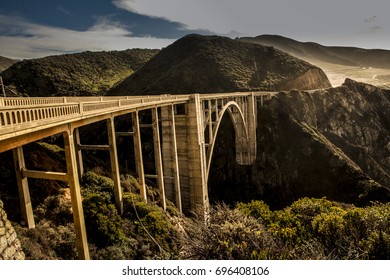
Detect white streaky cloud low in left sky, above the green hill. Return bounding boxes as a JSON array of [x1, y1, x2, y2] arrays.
[[0, 15, 173, 58]]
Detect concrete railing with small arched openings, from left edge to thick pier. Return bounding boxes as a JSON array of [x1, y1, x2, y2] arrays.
[[0, 95, 189, 135]]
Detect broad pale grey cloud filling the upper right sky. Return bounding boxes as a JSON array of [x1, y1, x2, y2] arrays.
[[112, 0, 390, 48]]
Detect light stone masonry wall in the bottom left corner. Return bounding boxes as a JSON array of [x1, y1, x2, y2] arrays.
[[0, 200, 25, 260]]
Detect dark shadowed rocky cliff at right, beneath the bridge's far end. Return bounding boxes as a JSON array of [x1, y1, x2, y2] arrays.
[[209, 80, 390, 208]]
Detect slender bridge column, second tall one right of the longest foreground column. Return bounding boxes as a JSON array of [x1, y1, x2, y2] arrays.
[[132, 111, 147, 202]]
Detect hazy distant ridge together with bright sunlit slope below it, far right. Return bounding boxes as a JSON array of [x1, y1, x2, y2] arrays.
[[238, 35, 390, 88]]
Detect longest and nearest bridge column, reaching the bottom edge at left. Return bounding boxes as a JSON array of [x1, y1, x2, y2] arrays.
[[63, 129, 89, 260]]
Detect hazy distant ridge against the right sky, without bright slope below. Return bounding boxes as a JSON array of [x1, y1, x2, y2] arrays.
[[238, 35, 390, 69]]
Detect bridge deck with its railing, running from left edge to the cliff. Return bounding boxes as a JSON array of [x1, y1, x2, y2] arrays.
[[0, 92, 272, 152]]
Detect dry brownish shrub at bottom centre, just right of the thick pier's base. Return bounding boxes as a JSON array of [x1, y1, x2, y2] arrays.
[[183, 205, 279, 259]]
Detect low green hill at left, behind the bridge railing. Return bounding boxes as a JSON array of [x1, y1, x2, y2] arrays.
[[1, 49, 159, 96]]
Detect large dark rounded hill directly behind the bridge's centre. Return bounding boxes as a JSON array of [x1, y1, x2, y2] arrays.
[[109, 35, 331, 95]]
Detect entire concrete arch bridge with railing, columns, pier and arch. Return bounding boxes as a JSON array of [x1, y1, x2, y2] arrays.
[[0, 92, 273, 259]]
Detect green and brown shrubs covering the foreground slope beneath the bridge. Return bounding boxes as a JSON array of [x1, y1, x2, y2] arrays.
[[11, 170, 390, 260]]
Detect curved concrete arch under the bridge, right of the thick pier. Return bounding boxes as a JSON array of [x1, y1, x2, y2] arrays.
[[206, 101, 250, 181]]
